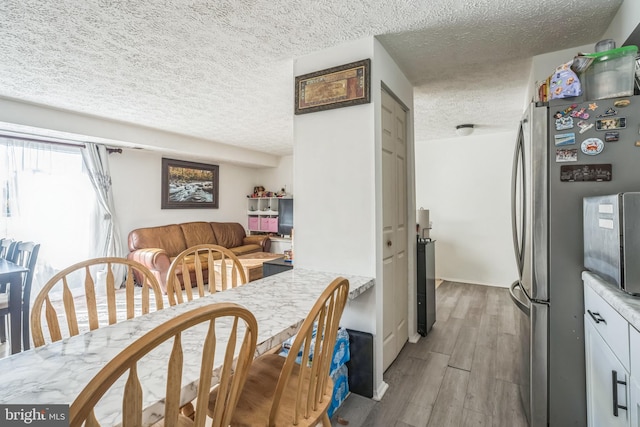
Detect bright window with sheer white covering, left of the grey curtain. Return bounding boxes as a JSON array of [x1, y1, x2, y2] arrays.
[[0, 138, 98, 296]]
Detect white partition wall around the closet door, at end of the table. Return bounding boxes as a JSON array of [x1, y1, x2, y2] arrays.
[[294, 38, 415, 397]]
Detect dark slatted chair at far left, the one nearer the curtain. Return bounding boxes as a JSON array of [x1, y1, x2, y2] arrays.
[[0, 242, 40, 350]]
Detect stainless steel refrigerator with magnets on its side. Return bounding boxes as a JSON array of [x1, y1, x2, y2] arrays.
[[510, 96, 640, 427]]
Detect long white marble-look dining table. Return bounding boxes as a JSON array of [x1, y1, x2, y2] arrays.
[[0, 268, 374, 425]]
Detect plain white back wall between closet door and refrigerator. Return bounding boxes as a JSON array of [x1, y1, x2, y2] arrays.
[[416, 129, 518, 287]]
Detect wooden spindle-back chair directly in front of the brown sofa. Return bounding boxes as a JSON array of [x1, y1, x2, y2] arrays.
[[167, 244, 247, 305]]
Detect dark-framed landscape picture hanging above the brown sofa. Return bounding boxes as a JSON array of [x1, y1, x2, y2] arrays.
[[160, 158, 219, 209]]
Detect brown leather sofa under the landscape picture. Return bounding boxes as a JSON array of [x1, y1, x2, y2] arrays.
[[127, 221, 271, 292]]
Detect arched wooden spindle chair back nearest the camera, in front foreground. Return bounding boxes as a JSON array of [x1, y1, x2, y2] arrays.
[[69, 303, 258, 427]]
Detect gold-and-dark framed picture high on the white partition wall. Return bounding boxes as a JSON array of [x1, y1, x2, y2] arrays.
[[295, 59, 371, 114]]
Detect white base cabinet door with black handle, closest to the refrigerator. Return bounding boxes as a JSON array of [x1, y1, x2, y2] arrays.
[[584, 314, 630, 427]]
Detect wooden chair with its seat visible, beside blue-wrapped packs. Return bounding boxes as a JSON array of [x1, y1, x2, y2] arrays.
[[209, 277, 349, 427]]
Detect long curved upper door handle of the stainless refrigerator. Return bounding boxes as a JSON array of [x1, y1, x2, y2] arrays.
[[511, 123, 527, 278]]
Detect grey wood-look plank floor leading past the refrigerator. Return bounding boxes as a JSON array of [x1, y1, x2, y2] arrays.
[[332, 281, 527, 427]]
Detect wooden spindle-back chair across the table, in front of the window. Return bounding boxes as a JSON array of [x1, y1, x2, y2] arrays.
[[31, 257, 163, 347]]
